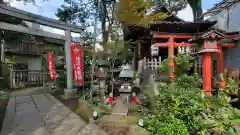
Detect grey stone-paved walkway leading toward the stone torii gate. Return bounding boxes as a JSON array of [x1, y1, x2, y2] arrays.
[[0, 94, 86, 135]]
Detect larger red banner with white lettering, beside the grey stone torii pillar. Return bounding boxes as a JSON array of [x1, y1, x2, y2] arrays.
[[71, 44, 84, 85]]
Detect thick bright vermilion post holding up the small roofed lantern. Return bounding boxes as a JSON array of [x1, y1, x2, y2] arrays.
[[202, 53, 212, 96]]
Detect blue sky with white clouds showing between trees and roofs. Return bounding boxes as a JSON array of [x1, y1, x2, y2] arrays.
[[5, 0, 222, 34]]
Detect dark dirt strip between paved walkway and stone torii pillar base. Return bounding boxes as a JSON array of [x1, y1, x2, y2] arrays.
[[51, 90, 78, 112]]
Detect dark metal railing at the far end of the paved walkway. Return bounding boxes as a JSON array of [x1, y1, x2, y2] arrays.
[[10, 70, 50, 89]]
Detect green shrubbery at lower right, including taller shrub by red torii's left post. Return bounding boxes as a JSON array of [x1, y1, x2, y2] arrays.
[[144, 56, 239, 135]]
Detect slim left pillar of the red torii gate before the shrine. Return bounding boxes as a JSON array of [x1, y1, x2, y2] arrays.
[[168, 37, 175, 87]]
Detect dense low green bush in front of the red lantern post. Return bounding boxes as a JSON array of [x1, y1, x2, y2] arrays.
[[142, 77, 239, 135]]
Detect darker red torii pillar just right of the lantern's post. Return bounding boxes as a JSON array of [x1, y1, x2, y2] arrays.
[[216, 42, 224, 88]]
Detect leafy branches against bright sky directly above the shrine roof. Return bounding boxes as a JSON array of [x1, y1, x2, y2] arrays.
[[152, 0, 188, 15]]
